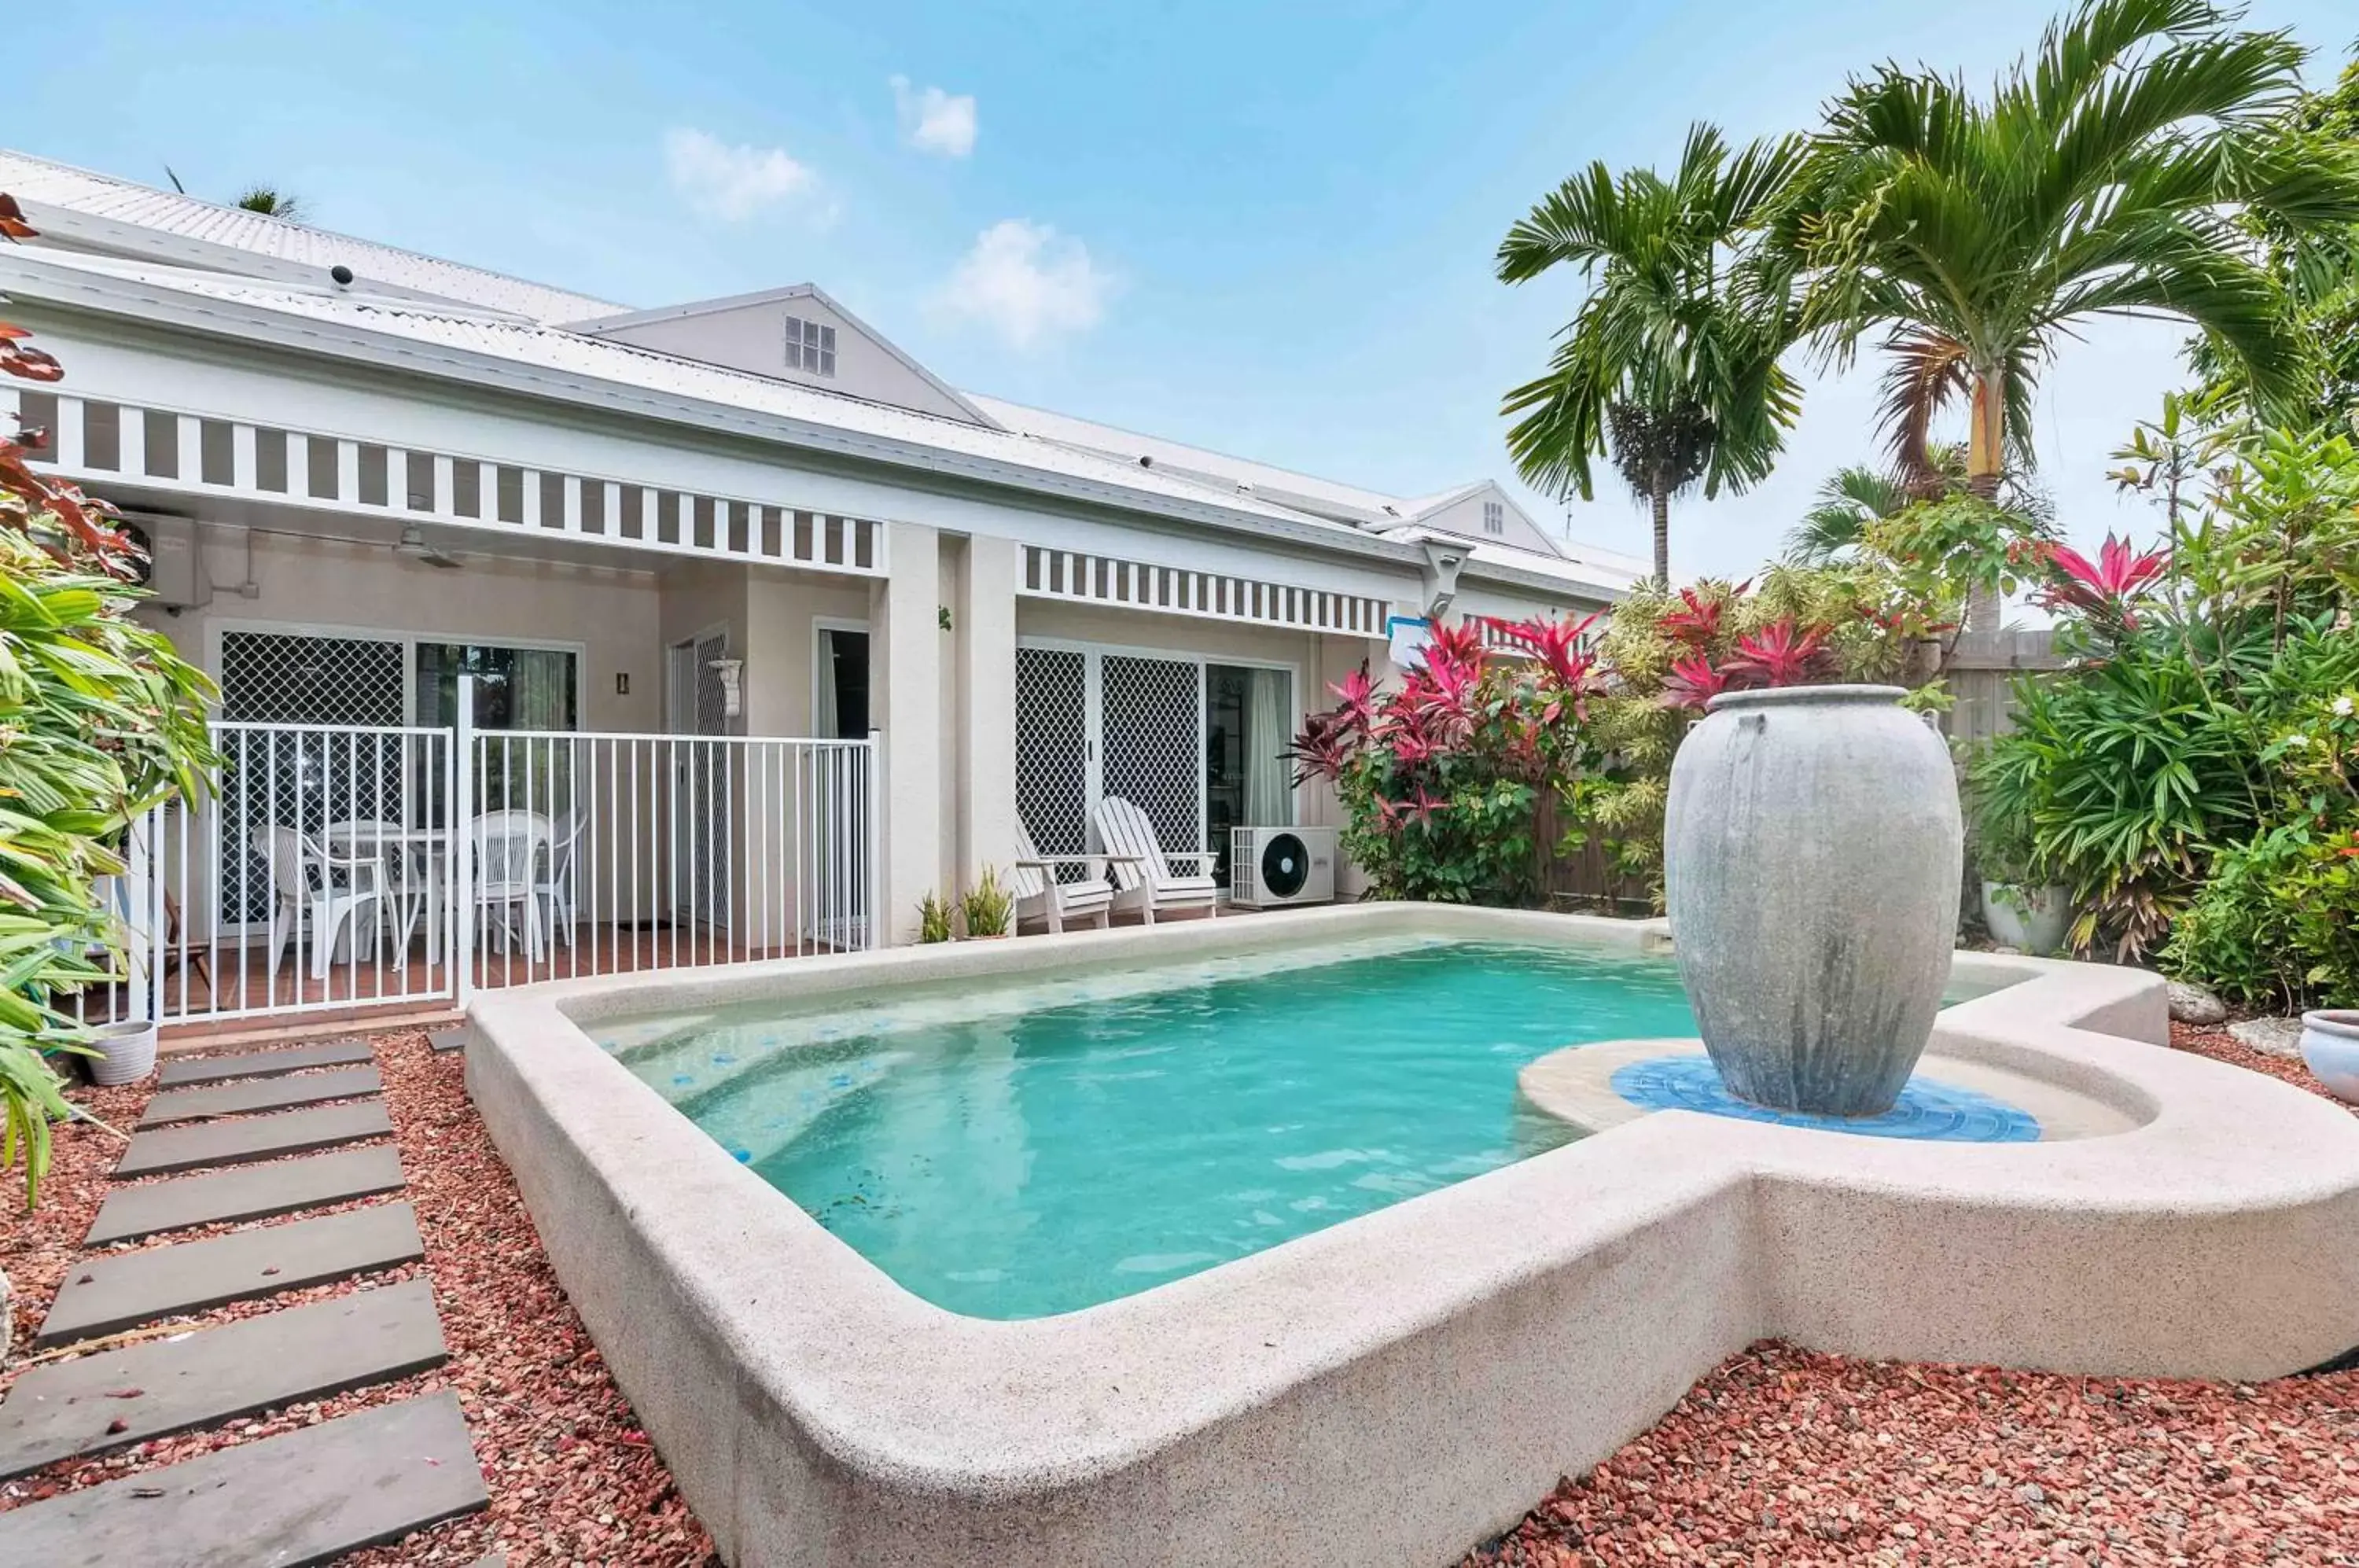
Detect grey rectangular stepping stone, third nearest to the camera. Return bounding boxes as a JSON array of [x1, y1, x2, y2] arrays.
[[38, 1202, 425, 1349]]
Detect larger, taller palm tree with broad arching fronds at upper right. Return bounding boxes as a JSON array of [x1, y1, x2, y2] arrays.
[[1765, 0, 2359, 518]]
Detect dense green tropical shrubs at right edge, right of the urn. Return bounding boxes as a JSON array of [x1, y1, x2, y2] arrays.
[[1972, 408, 2359, 985]]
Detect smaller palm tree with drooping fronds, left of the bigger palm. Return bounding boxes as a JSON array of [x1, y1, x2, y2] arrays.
[[1498, 125, 1802, 585]]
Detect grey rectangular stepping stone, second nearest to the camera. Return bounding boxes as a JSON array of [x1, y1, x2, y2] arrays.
[[0, 1280, 448, 1481]]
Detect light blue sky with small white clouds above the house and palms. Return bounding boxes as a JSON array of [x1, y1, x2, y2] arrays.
[[18, 0, 2359, 576]]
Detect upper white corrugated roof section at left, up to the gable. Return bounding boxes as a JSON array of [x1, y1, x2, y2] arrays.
[[0, 151, 625, 321]]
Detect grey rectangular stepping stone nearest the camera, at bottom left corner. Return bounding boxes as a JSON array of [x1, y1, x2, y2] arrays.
[[0, 1389, 491, 1568]]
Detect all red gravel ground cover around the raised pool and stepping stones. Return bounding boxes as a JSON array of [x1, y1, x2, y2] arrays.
[[18, 1009, 2359, 1568]]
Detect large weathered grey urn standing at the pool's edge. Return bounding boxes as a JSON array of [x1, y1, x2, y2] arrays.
[[1663, 686, 1965, 1115]]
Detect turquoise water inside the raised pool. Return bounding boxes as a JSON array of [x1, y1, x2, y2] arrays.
[[606, 943, 1694, 1318]]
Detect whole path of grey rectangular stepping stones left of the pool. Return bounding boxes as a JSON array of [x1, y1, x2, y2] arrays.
[[0, 1040, 498, 1568]]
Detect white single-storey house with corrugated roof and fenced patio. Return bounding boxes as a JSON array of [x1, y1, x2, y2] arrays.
[[0, 153, 1644, 1021]]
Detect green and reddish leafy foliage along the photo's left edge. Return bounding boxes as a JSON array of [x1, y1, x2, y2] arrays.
[[0, 196, 210, 1202]]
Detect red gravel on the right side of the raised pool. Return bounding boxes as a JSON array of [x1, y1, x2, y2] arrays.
[[1460, 1025, 2359, 1568]]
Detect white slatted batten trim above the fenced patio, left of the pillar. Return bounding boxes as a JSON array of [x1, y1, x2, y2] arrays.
[[0, 389, 887, 578]]
